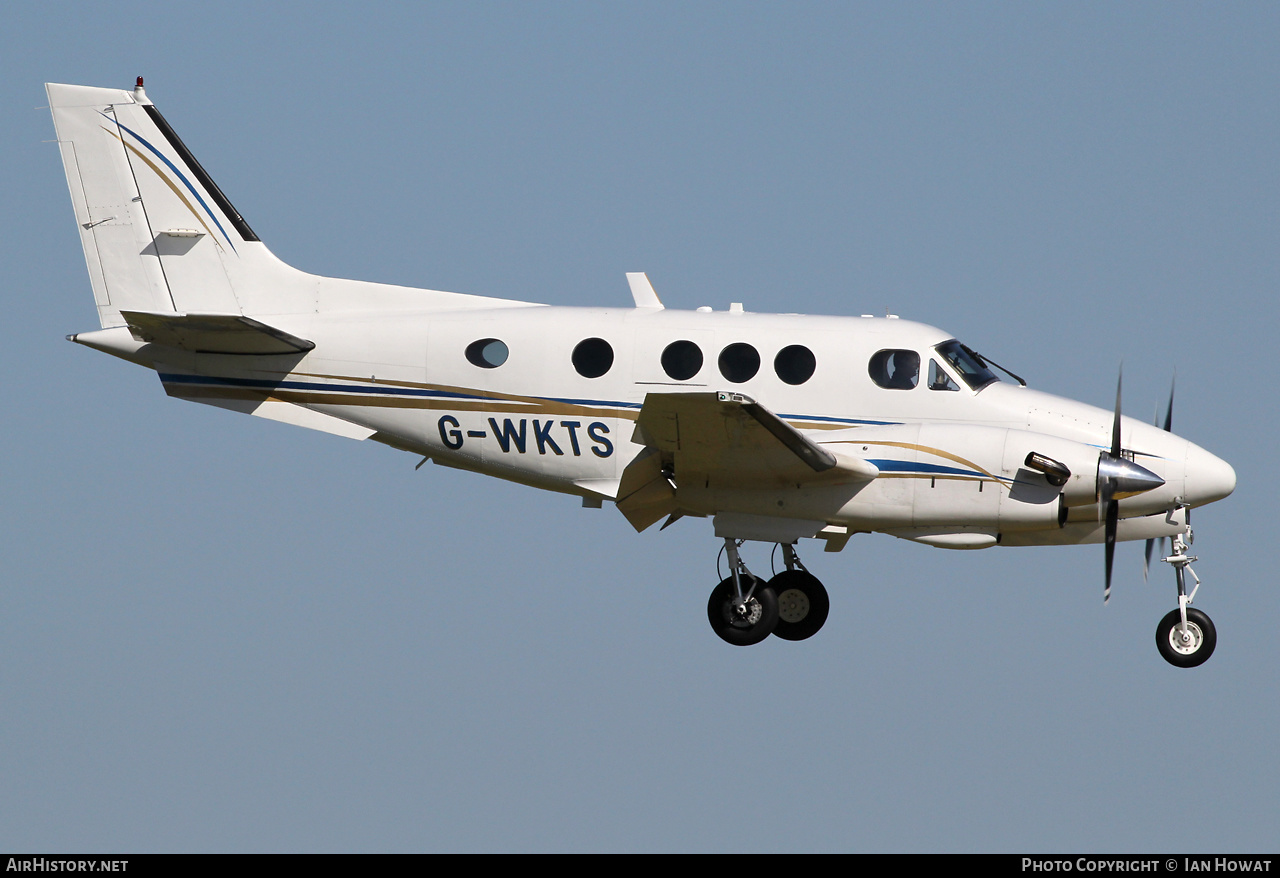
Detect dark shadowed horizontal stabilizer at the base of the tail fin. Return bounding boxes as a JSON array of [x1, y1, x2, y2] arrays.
[[120, 311, 315, 355]]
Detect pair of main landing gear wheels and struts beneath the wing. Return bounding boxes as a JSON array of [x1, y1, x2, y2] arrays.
[[707, 538, 831, 646]]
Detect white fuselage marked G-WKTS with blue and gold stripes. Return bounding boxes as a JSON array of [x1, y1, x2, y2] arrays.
[[127, 297, 1235, 548]]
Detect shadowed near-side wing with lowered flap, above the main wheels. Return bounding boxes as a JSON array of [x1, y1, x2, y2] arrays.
[[618, 390, 879, 531]]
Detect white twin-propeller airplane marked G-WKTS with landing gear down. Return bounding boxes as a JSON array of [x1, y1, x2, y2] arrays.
[[46, 77, 1235, 668]]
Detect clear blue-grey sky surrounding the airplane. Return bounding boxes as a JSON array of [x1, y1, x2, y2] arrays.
[[0, 3, 1280, 852]]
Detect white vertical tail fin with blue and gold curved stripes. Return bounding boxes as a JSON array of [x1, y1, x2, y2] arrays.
[[45, 77, 290, 326]]
